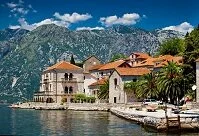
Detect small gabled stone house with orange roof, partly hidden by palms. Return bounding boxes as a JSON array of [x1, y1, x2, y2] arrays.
[[109, 68, 150, 103]]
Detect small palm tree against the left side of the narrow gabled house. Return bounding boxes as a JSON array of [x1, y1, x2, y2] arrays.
[[97, 80, 109, 100]]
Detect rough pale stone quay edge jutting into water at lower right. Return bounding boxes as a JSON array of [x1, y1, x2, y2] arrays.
[[110, 107, 199, 132]]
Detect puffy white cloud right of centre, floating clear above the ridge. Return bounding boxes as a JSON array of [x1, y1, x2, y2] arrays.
[[100, 13, 141, 27]]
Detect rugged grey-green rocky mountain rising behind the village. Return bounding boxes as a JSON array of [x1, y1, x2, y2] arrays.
[[0, 24, 185, 101]]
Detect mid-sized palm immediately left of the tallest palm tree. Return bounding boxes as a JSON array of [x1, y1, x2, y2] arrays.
[[136, 72, 159, 98]]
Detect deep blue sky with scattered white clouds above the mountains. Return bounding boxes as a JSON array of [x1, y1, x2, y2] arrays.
[[0, 0, 199, 33]]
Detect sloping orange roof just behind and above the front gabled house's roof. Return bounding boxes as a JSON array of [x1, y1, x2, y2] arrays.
[[99, 60, 130, 70]]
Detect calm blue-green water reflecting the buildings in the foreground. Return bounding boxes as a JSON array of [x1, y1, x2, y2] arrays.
[[0, 105, 198, 136]]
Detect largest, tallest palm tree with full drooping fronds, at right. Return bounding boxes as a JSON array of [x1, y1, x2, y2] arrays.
[[158, 61, 184, 104]]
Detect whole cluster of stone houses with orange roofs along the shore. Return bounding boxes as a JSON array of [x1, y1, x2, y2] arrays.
[[33, 52, 182, 103]]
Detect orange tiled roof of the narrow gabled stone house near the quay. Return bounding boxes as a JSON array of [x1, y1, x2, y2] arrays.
[[116, 68, 151, 76]]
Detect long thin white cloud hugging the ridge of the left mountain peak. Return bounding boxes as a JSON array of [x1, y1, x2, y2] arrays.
[[9, 18, 69, 31]]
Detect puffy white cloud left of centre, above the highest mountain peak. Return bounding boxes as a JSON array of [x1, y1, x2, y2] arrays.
[[54, 12, 92, 23]]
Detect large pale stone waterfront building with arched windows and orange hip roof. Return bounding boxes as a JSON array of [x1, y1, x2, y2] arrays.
[[34, 61, 84, 103]]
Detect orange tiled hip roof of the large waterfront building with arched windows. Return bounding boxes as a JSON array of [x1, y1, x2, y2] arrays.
[[45, 61, 82, 71]]
